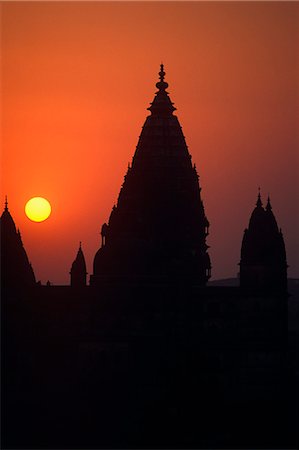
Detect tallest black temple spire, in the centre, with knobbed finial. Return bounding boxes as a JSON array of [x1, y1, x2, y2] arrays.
[[91, 64, 211, 285]]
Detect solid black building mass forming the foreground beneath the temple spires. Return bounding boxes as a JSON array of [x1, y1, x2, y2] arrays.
[[2, 285, 298, 449]]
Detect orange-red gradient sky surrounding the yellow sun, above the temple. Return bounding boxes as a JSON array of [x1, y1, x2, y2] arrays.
[[1, 2, 299, 284]]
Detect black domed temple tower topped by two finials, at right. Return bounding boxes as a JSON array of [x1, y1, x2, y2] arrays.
[[240, 193, 288, 292]]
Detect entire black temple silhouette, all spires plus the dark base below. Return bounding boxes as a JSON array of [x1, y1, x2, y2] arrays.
[[1, 65, 297, 448]]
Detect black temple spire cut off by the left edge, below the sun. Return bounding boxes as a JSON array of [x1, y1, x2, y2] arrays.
[[0, 200, 35, 289]]
